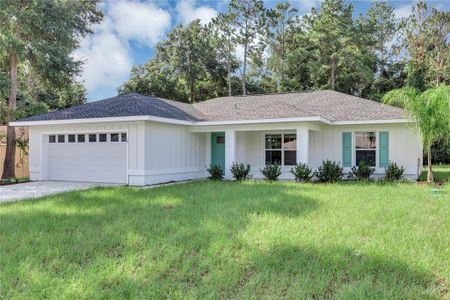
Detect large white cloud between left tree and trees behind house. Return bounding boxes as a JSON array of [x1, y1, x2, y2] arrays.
[[74, 0, 170, 100]]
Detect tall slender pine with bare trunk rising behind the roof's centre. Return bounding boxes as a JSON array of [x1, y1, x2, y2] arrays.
[[228, 0, 265, 95]]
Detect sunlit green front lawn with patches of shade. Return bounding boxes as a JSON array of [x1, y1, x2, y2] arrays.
[[0, 181, 450, 299]]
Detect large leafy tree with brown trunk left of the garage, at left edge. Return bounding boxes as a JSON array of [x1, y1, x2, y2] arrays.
[[0, 0, 102, 178]]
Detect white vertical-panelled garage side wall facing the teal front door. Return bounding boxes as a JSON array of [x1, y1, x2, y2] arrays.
[[140, 122, 209, 185]]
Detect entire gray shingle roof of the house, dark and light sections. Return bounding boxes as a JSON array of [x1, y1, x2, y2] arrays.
[[17, 90, 404, 121]]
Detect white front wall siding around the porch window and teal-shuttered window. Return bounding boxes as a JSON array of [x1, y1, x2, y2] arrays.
[[236, 124, 422, 179]]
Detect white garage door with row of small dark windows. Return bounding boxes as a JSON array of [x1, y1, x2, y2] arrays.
[[47, 132, 127, 183]]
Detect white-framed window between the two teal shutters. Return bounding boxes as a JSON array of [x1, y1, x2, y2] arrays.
[[355, 131, 377, 167]]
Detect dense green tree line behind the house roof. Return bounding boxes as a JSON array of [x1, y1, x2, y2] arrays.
[[118, 0, 450, 102]]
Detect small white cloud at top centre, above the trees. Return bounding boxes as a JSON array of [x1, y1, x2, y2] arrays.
[[176, 0, 218, 25]]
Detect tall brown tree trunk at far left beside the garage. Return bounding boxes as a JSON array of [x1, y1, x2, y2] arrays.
[[2, 53, 17, 178]]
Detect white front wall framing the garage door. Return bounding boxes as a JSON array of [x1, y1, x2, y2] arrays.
[[29, 121, 145, 183]]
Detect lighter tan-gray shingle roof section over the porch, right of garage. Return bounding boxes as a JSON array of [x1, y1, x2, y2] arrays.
[[194, 90, 404, 122]]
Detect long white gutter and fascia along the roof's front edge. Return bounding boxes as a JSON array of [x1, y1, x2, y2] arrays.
[[9, 116, 410, 126]]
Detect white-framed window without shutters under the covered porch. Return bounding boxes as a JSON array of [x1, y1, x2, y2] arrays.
[[264, 133, 297, 166]]
